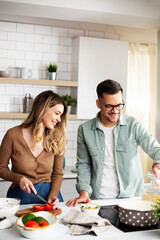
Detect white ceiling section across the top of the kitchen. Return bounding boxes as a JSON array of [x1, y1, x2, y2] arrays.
[[0, 0, 160, 29]]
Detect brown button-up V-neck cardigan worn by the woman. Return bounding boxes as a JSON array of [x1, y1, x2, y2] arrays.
[[0, 126, 64, 197]]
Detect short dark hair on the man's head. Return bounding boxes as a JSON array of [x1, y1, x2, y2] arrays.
[[97, 79, 123, 98]]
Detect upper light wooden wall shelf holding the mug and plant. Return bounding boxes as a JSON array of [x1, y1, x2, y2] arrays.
[[0, 77, 78, 87]]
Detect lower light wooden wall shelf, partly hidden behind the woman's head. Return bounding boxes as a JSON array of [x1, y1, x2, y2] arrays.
[[0, 112, 77, 120]]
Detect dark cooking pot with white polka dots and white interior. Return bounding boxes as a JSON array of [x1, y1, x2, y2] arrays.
[[114, 200, 158, 227]]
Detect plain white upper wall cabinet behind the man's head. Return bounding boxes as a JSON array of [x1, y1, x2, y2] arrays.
[[72, 37, 128, 119]]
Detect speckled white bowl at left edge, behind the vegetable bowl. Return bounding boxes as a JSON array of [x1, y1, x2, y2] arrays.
[[0, 198, 20, 218]]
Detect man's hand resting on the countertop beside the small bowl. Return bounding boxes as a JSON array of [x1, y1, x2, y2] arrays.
[[66, 191, 91, 207]]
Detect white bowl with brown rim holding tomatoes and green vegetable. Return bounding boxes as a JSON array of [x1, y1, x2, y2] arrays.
[[16, 211, 57, 238]]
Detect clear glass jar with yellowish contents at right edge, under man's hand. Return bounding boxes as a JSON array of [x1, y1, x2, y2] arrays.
[[142, 171, 160, 202]]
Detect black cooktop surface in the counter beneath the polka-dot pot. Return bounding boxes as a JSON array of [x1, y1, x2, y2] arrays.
[[99, 205, 160, 232]]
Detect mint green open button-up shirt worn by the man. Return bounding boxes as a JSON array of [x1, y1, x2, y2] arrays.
[[76, 115, 160, 199]]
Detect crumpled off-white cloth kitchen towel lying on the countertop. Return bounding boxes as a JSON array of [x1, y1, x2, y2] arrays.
[[62, 208, 111, 236]]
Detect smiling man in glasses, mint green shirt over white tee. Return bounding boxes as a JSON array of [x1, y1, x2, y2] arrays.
[[67, 80, 160, 206]]
